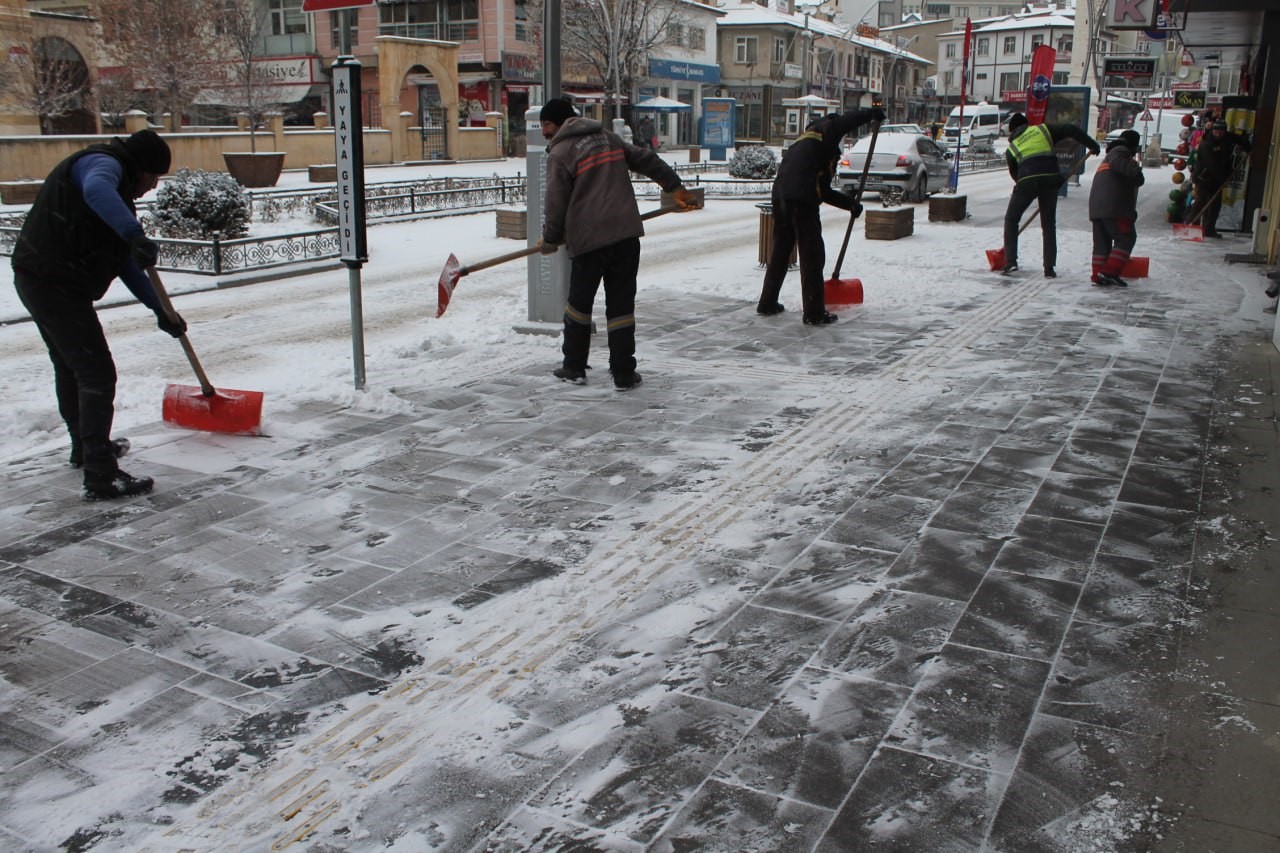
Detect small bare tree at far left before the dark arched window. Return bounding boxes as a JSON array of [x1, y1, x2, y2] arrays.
[[5, 37, 90, 136]]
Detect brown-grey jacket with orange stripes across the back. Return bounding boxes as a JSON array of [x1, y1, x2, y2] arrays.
[[543, 118, 681, 257]]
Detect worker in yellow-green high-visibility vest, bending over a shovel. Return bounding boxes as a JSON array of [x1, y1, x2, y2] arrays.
[[1000, 113, 1102, 278]]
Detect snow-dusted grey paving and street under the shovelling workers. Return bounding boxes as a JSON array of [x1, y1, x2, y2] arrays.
[[0, 149, 1280, 850]]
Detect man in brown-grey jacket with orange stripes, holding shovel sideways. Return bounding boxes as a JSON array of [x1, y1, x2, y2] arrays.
[[540, 97, 698, 391]]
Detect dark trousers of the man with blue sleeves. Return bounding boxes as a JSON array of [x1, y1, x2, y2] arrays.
[[13, 270, 116, 475]]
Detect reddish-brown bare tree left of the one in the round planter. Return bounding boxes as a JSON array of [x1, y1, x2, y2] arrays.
[[97, 0, 224, 126]]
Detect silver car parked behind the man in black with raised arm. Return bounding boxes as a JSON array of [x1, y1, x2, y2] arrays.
[[836, 133, 951, 202]]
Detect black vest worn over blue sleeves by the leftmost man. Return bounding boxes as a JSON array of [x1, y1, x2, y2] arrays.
[[13, 140, 154, 300]]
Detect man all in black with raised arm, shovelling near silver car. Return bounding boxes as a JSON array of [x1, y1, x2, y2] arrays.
[[755, 108, 884, 325]]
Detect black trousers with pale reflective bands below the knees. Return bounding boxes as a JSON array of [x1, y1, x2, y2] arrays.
[[561, 237, 640, 377]]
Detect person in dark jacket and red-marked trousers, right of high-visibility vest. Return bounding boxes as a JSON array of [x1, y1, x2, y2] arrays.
[[1089, 131, 1146, 287]]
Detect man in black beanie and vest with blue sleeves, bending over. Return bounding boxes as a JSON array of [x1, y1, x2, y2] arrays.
[[13, 131, 187, 501]]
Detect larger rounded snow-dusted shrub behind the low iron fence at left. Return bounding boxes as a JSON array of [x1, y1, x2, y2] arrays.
[[154, 169, 250, 240]]
